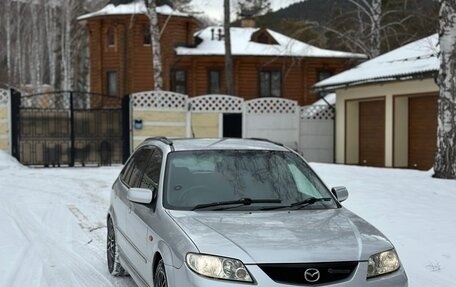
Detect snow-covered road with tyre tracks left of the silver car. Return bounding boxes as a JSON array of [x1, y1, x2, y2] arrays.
[[0, 153, 136, 287]]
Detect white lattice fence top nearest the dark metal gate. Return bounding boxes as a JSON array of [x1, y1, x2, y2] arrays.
[[133, 91, 188, 111]]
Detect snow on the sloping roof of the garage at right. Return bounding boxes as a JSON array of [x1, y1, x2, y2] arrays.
[[314, 34, 440, 88]]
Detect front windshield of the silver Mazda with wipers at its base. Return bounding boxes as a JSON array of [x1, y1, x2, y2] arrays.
[[163, 150, 338, 210]]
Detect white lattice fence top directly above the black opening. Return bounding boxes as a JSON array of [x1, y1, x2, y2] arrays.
[[190, 95, 244, 113]]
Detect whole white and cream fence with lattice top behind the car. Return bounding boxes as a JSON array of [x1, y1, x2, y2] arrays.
[[132, 92, 334, 162]]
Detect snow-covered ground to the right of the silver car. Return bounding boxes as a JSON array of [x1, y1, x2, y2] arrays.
[[312, 164, 456, 287]]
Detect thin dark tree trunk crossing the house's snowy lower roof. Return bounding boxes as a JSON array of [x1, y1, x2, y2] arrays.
[[223, 0, 234, 95]]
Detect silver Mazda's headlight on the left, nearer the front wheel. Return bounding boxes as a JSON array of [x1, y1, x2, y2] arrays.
[[185, 253, 253, 282]]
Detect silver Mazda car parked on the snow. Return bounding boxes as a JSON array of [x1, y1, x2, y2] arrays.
[[107, 138, 407, 287]]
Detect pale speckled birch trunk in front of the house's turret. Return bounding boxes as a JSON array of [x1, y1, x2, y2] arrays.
[[144, 0, 163, 91]]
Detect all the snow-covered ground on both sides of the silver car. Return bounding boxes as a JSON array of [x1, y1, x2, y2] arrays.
[[0, 152, 456, 287]]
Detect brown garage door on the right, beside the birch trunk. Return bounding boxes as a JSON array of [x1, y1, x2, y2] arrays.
[[408, 95, 438, 170]]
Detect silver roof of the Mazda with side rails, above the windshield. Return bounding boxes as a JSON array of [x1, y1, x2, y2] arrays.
[[144, 138, 288, 151]]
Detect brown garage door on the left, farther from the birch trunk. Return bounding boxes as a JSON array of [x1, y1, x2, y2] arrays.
[[359, 99, 385, 167]]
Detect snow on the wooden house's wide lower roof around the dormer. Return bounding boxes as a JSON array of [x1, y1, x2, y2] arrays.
[[176, 26, 366, 58]]
